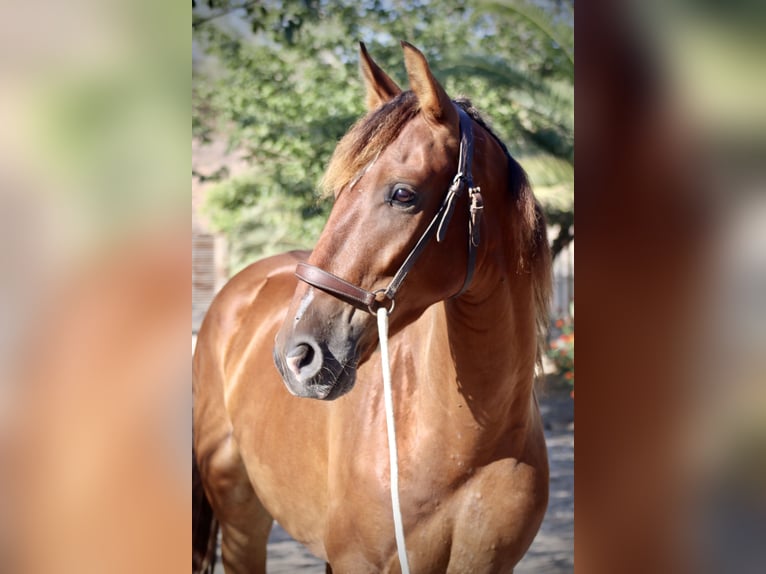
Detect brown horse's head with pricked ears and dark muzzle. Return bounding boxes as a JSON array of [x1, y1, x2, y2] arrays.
[[274, 42, 520, 399]]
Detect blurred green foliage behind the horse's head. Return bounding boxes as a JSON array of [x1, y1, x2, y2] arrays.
[[192, 0, 574, 270]]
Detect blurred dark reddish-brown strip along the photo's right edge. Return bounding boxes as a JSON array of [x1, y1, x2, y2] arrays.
[[575, 0, 766, 572]]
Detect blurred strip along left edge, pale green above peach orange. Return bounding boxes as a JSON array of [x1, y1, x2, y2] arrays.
[[0, 0, 191, 573]]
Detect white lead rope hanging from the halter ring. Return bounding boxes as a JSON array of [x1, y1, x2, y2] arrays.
[[377, 307, 410, 574]]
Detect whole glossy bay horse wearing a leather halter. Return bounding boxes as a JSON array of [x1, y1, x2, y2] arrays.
[[193, 42, 550, 574]]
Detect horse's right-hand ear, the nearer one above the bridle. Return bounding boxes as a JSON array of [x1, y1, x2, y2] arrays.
[[402, 40, 459, 129]]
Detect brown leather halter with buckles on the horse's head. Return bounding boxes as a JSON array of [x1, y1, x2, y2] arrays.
[[295, 106, 484, 315]]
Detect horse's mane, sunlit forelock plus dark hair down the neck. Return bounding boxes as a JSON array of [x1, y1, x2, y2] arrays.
[[321, 90, 552, 372]]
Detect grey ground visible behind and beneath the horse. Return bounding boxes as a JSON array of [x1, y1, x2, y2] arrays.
[[216, 377, 574, 574]]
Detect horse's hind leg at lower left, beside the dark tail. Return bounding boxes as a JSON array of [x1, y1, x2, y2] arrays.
[[200, 435, 274, 574]]
